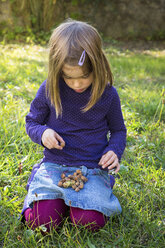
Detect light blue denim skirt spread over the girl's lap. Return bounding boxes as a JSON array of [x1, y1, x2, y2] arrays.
[[22, 162, 122, 216]]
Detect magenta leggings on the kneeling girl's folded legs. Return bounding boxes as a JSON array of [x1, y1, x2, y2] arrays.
[[24, 199, 106, 232]]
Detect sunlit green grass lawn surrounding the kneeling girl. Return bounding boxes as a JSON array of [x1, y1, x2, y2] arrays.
[[0, 44, 165, 248]]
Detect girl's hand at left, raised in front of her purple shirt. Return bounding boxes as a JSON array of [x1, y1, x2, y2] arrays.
[[41, 128, 65, 150]]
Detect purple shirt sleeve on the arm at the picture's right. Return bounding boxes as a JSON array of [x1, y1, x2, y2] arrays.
[[103, 87, 127, 160]]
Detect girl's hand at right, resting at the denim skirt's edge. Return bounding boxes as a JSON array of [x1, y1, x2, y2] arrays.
[[99, 151, 120, 173]]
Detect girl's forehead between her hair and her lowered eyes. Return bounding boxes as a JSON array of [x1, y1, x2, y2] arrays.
[[62, 64, 85, 77]]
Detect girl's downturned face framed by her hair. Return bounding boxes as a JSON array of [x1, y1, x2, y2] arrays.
[[62, 64, 93, 93]]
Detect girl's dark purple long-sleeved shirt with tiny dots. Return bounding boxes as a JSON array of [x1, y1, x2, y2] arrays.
[[26, 79, 126, 168]]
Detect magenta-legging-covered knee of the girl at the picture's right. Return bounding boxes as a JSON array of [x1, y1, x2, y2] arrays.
[[70, 207, 106, 231]]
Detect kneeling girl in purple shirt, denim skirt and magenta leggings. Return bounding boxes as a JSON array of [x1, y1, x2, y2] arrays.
[[22, 21, 126, 231]]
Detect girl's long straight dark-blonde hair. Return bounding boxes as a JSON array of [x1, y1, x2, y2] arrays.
[[46, 20, 113, 117]]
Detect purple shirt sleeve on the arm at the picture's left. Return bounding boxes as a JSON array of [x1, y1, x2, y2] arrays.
[[26, 82, 50, 145]]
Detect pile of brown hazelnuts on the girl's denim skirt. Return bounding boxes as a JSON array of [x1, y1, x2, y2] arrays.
[[58, 170, 88, 192]]
